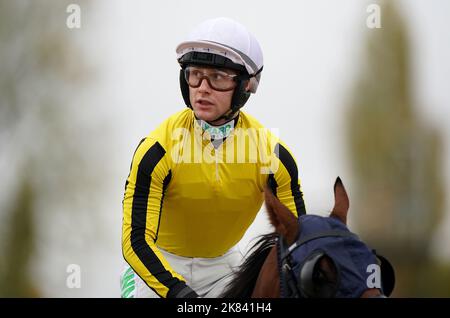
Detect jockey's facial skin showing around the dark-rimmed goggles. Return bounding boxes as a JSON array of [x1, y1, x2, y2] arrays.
[[189, 67, 236, 125]]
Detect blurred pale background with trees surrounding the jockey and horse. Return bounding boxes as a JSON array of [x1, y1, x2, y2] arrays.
[[0, 0, 450, 297]]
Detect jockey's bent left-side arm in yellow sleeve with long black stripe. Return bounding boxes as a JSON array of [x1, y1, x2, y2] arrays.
[[122, 138, 196, 298]]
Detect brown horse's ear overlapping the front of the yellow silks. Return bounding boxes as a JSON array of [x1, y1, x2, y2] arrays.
[[264, 187, 299, 244]]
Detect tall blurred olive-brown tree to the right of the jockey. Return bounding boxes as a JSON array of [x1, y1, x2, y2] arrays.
[[346, 1, 448, 296]]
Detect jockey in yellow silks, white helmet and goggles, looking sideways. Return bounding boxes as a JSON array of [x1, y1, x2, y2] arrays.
[[121, 18, 305, 298]]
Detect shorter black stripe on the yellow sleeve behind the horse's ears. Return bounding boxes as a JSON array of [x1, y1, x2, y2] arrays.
[[275, 143, 306, 216]]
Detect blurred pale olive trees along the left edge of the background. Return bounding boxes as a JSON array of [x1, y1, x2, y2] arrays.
[[0, 0, 101, 297]]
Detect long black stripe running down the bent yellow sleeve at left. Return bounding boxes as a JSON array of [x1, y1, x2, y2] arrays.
[[131, 142, 179, 289]]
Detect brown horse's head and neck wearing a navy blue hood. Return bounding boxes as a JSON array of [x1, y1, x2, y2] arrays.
[[222, 178, 395, 298]]
